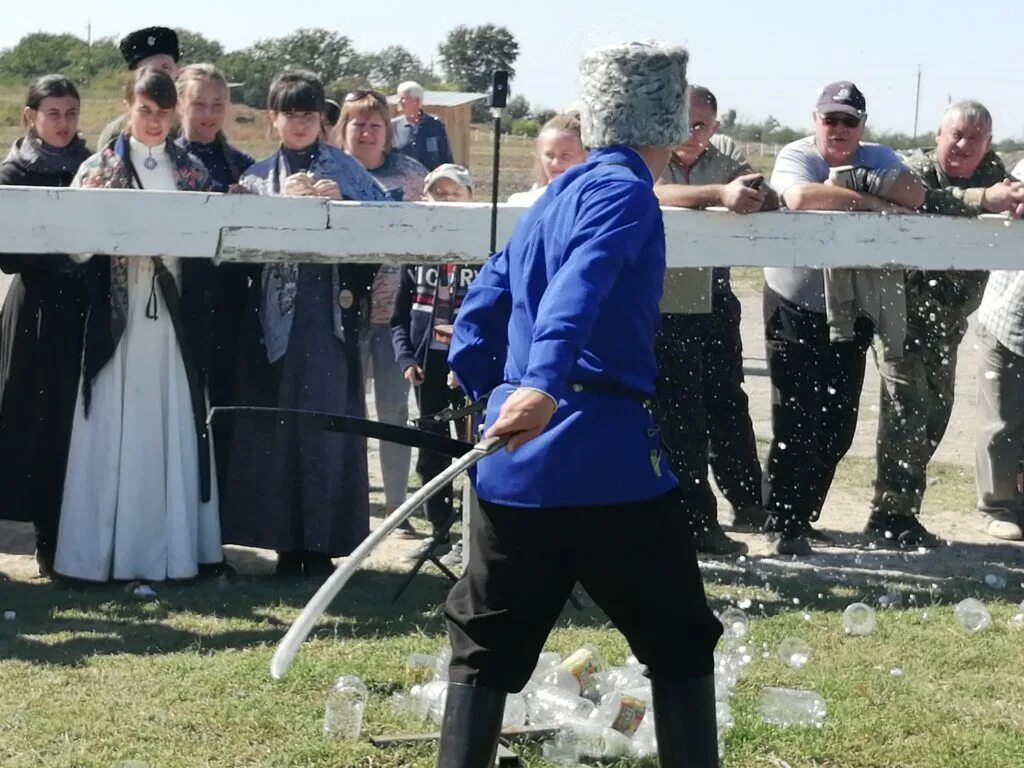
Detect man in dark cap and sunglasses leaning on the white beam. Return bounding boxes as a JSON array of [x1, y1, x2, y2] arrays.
[[764, 82, 925, 555]]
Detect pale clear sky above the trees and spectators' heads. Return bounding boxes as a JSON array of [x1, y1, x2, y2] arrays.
[[8, 0, 1024, 138]]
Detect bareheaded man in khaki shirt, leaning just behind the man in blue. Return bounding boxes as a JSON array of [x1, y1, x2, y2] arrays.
[[654, 86, 778, 554]]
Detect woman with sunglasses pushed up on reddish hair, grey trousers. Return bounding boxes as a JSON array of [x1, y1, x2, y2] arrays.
[[338, 90, 427, 534]]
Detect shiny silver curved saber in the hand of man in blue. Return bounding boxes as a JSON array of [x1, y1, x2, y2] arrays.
[[270, 435, 510, 680]]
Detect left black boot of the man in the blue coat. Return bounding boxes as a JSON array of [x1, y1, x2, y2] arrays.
[[437, 683, 507, 768]]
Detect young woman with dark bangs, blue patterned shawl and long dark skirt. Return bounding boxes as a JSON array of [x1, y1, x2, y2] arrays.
[[223, 71, 384, 577]]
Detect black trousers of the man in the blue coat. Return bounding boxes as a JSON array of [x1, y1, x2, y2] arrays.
[[445, 492, 722, 692]]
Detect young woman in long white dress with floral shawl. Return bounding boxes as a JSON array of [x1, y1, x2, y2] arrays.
[[55, 70, 222, 582]]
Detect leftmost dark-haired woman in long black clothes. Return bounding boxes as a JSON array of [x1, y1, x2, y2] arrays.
[[0, 75, 89, 575]]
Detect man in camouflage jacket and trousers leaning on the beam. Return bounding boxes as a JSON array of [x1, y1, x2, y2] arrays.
[[866, 101, 1024, 549]]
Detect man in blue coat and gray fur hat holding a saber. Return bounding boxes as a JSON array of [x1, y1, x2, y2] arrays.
[[437, 44, 722, 768]]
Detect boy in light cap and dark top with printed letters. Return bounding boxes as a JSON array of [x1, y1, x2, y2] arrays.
[[391, 163, 477, 558]]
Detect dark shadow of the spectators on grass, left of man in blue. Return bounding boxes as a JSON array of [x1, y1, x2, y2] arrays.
[[0, 570, 607, 666]]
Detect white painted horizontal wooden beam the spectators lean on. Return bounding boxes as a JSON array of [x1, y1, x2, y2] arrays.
[[0, 186, 1024, 269]]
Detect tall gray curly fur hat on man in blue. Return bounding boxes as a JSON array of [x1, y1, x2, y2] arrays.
[[580, 43, 690, 148]]
